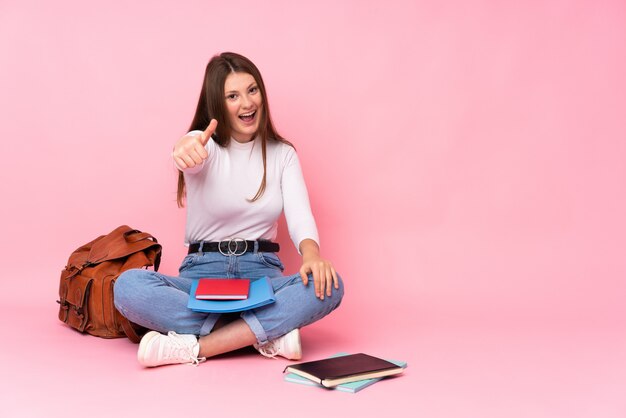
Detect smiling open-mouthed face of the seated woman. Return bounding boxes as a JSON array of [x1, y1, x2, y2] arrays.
[[224, 72, 263, 142]]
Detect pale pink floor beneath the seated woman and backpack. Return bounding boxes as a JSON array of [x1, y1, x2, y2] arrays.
[[0, 304, 626, 418]]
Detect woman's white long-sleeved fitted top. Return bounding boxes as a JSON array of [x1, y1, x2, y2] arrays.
[[177, 131, 319, 251]]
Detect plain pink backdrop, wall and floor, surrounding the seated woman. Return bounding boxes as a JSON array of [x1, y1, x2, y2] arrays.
[[0, 0, 626, 417]]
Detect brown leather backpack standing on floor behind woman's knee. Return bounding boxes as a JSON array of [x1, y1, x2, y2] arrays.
[[57, 225, 161, 343]]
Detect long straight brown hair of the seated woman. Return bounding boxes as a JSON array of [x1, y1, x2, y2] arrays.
[[176, 52, 293, 207]]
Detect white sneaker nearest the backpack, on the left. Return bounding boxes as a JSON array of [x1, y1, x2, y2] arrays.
[[137, 331, 206, 367]]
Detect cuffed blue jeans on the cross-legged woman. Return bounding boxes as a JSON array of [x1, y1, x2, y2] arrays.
[[114, 251, 343, 345]]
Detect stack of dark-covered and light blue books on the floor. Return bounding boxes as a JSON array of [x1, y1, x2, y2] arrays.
[[284, 353, 407, 393]]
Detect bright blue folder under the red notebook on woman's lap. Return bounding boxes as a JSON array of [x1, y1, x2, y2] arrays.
[[187, 277, 276, 313]]
